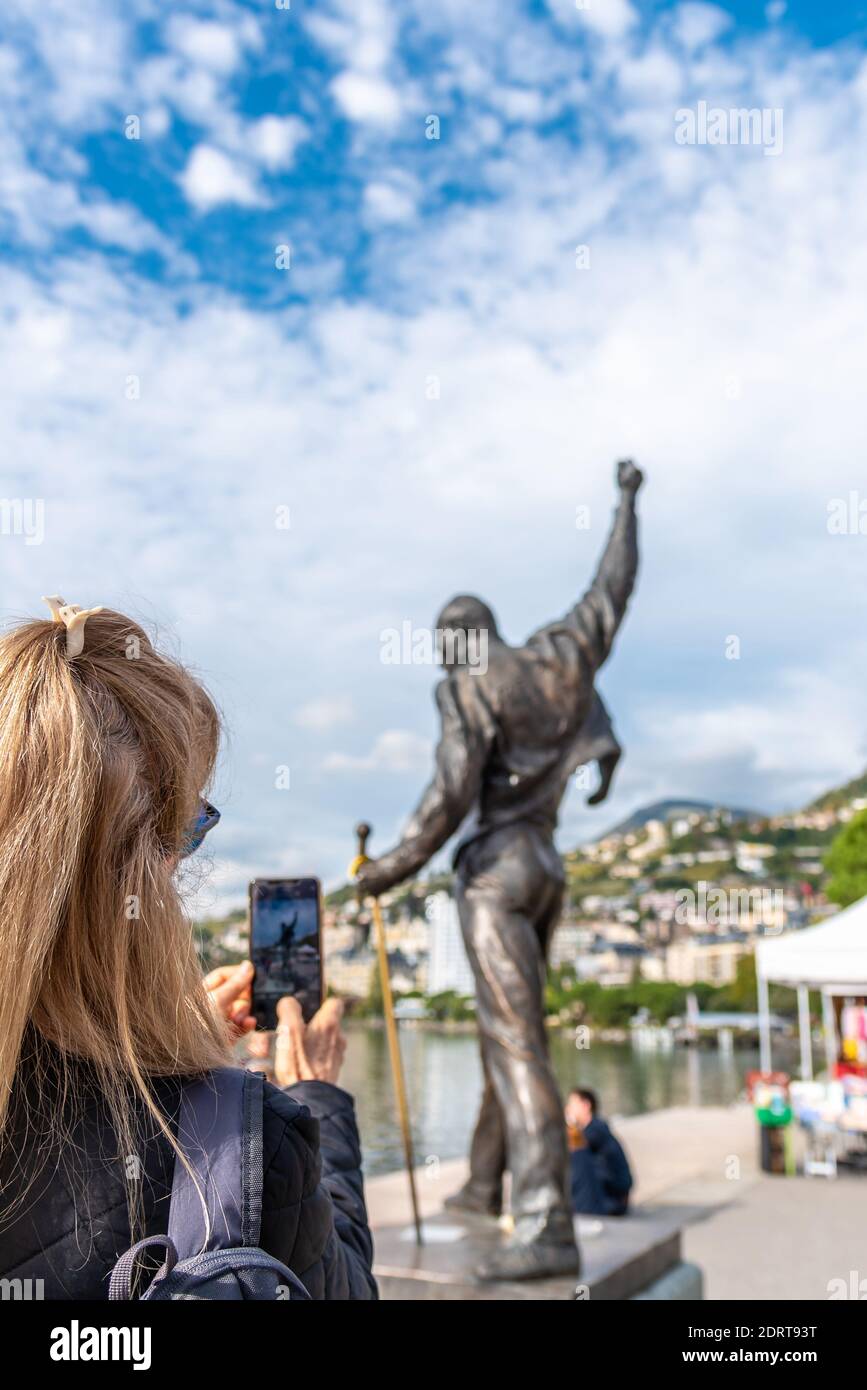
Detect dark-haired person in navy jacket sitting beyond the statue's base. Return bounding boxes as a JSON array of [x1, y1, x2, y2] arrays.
[[565, 1088, 632, 1216]]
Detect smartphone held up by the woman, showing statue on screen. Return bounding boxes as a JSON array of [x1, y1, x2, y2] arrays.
[[250, 878, 322, 1029]]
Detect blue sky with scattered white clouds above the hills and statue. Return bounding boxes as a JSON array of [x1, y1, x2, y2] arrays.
[[0, 0, 867, 908]]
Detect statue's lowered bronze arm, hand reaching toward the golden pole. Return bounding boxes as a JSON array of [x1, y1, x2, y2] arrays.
[[352, 674, 490, 895]]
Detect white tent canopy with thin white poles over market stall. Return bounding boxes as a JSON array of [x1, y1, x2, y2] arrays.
[[756, 898, 867, 1079]]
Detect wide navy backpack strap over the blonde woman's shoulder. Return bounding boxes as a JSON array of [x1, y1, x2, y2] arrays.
[[168, 1068, 264, 1259]]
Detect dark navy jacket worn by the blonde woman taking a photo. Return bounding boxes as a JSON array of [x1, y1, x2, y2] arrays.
[[0, 1056, 377, 1300]]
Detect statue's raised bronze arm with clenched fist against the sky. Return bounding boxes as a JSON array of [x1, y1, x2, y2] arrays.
[[532, 460, 643, 670]]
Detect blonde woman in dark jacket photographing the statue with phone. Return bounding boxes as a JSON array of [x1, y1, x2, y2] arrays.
[[0, 599, 377, 1300]]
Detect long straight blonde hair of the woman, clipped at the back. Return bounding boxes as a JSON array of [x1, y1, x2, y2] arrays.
[[0, 609, 229, 1229]]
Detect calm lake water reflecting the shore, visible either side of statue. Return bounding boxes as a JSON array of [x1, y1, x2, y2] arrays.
[[340, 1026, 786, 1175]]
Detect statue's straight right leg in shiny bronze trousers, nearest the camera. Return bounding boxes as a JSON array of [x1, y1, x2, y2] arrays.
[[461, 828, 574, 1267]]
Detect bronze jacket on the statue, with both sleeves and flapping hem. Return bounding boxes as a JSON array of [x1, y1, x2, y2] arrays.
[[366, 493, 638, 883]]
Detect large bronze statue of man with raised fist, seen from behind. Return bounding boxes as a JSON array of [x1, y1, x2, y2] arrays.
[[358, 461, 642, 1279]]
